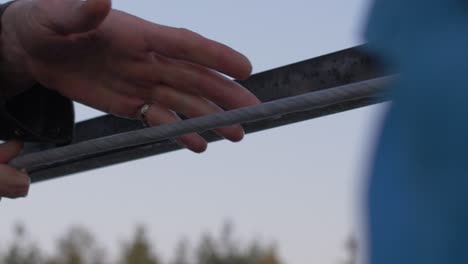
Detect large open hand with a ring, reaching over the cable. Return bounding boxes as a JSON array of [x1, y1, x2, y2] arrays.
[[2, 0, 259, 152]]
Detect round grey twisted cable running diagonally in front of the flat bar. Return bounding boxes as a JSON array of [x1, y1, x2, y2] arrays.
[[10, 77, 392, 174]]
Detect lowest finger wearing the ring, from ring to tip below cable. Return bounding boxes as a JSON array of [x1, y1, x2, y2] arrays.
[[146, 103, 208, 153]]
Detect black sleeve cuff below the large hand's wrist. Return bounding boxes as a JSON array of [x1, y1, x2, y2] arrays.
[[0, 2, 74, 144]]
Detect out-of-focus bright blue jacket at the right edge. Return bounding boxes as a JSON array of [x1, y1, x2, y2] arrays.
[[366, 0, 468, 264]]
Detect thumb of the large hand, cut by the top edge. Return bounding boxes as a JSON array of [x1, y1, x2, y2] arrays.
[[41, 0, 112, 34]]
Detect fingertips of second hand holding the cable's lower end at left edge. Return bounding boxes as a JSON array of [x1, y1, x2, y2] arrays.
[[0, 141, 29, 198]]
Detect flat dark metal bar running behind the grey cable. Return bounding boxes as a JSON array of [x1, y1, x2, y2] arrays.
[[25, 44, 382, 182]]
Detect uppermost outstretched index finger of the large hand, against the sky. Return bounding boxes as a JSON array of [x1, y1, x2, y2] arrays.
[[144, 23, 252, 79]]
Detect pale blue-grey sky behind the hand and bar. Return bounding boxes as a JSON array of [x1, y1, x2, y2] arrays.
[[0, 0, 385, 264]]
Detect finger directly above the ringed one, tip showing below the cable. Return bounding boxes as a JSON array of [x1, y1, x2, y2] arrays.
[[152, 85, 244, 142]]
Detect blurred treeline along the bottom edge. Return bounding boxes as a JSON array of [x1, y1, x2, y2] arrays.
[[0, 224, 283, 264]]
